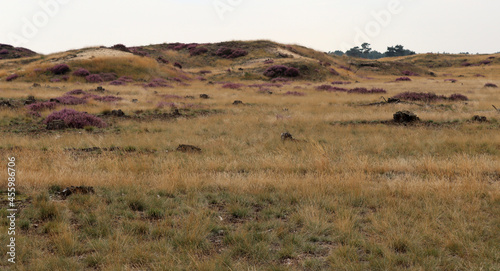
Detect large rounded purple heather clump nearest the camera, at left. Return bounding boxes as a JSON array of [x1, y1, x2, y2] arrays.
[[44, 108, 107, 129]]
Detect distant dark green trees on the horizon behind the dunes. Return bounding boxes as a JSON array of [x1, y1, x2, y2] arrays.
[[329, 42, 415, 59]]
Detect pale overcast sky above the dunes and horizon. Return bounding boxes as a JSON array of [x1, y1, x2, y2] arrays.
[[0, 0, 500, 53]]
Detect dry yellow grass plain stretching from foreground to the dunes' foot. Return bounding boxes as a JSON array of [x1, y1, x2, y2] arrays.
[[0, 41, 500, 270]]
